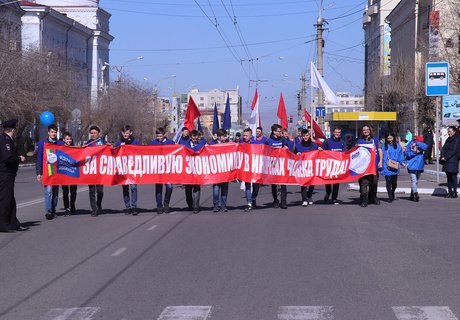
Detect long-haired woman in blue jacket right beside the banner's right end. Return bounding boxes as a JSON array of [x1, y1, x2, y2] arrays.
[[381, 133, 405, 203]]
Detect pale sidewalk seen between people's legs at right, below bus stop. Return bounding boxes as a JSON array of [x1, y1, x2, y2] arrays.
[[348, 164, 452, 196]]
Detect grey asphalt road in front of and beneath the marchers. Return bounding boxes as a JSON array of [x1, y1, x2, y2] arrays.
[[0, 168, 460, 320]]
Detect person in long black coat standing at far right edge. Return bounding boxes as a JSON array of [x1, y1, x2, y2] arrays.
[[441, 126, 459, 198]]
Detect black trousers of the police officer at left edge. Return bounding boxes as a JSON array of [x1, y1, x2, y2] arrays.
[[0, 175, 20, 232]]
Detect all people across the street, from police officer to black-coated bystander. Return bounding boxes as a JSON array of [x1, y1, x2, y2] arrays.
[[0, 120, 460, 231]]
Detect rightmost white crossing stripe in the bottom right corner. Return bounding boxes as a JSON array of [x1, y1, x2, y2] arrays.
[[392, 306, 458, 320]]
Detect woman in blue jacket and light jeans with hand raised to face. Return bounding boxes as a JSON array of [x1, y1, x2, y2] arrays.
[[404, 136, 428, 202]]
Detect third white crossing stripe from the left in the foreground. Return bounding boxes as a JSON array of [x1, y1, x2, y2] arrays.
[[278, 306, 334, 320]]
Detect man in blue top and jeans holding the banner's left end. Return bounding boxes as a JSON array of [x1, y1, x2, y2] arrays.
[[35, 124, 64, 220]]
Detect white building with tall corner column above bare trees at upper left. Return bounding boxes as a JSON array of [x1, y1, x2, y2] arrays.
[[21, 0, 113, 108]]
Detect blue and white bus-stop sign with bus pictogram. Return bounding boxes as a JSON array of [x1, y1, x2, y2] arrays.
[[425, 62, 449, 96]]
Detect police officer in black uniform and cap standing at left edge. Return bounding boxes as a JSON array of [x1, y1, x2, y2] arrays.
[[0, 119, 29, 232]]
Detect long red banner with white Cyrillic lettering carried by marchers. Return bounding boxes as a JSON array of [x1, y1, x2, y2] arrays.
[[43, 143, 376, 185]]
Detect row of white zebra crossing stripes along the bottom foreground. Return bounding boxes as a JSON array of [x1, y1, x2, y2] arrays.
[[40, 306, 458, 320]]
